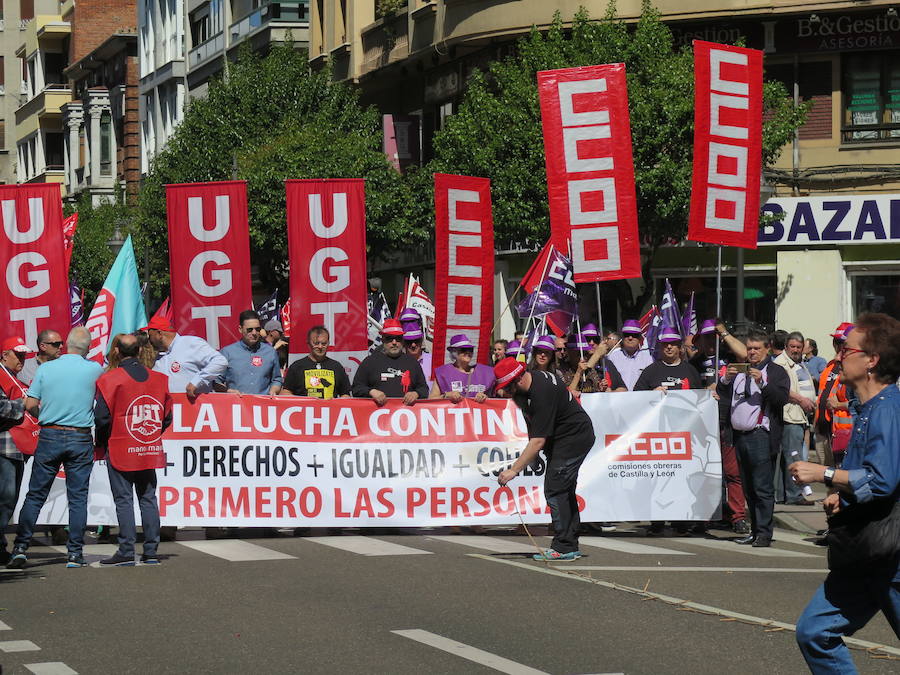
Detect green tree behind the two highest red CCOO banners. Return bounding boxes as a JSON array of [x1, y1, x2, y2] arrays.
[[430, 0, 806, 312]]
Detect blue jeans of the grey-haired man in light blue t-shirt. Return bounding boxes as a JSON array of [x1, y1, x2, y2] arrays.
[[15, 428, 94, 555]]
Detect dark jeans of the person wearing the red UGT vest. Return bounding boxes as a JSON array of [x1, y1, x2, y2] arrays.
[[106, 461, 159, 558]]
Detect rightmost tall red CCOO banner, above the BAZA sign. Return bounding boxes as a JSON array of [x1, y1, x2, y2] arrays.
[[688, 40, 762, 248]]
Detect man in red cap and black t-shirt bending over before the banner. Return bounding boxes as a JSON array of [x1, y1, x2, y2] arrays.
[[494, 357, 594, 562]]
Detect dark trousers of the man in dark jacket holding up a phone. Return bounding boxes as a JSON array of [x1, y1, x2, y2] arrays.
[[734, 429, 775, 540]]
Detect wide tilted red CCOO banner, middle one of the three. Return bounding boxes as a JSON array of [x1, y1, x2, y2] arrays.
[[538, 63, 641, 282]]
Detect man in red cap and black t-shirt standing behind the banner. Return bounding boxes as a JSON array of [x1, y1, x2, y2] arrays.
[[352, 319, 428, 406]]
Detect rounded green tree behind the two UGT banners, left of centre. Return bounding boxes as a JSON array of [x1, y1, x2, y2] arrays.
[[136, 45, 426, 297]]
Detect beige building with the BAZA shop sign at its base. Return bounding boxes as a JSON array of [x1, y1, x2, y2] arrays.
[[310, 0, 900, 343]]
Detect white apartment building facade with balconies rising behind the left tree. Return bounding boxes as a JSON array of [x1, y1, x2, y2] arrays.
[[138, 0, 309, 174]]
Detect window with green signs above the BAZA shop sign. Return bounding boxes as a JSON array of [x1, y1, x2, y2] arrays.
[[842, 52, 900, 143]]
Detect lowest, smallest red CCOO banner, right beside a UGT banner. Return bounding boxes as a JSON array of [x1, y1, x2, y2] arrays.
[[432, 173, 494, 367]]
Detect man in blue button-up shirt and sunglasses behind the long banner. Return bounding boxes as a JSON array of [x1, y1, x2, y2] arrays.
[[219, 309, 282, 395]]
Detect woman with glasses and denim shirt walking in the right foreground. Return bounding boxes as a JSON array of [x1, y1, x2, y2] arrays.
[[788, 314, 900, 673]]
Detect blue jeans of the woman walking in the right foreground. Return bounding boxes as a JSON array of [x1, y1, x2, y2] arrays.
[[797, 560, 900, 675]]
